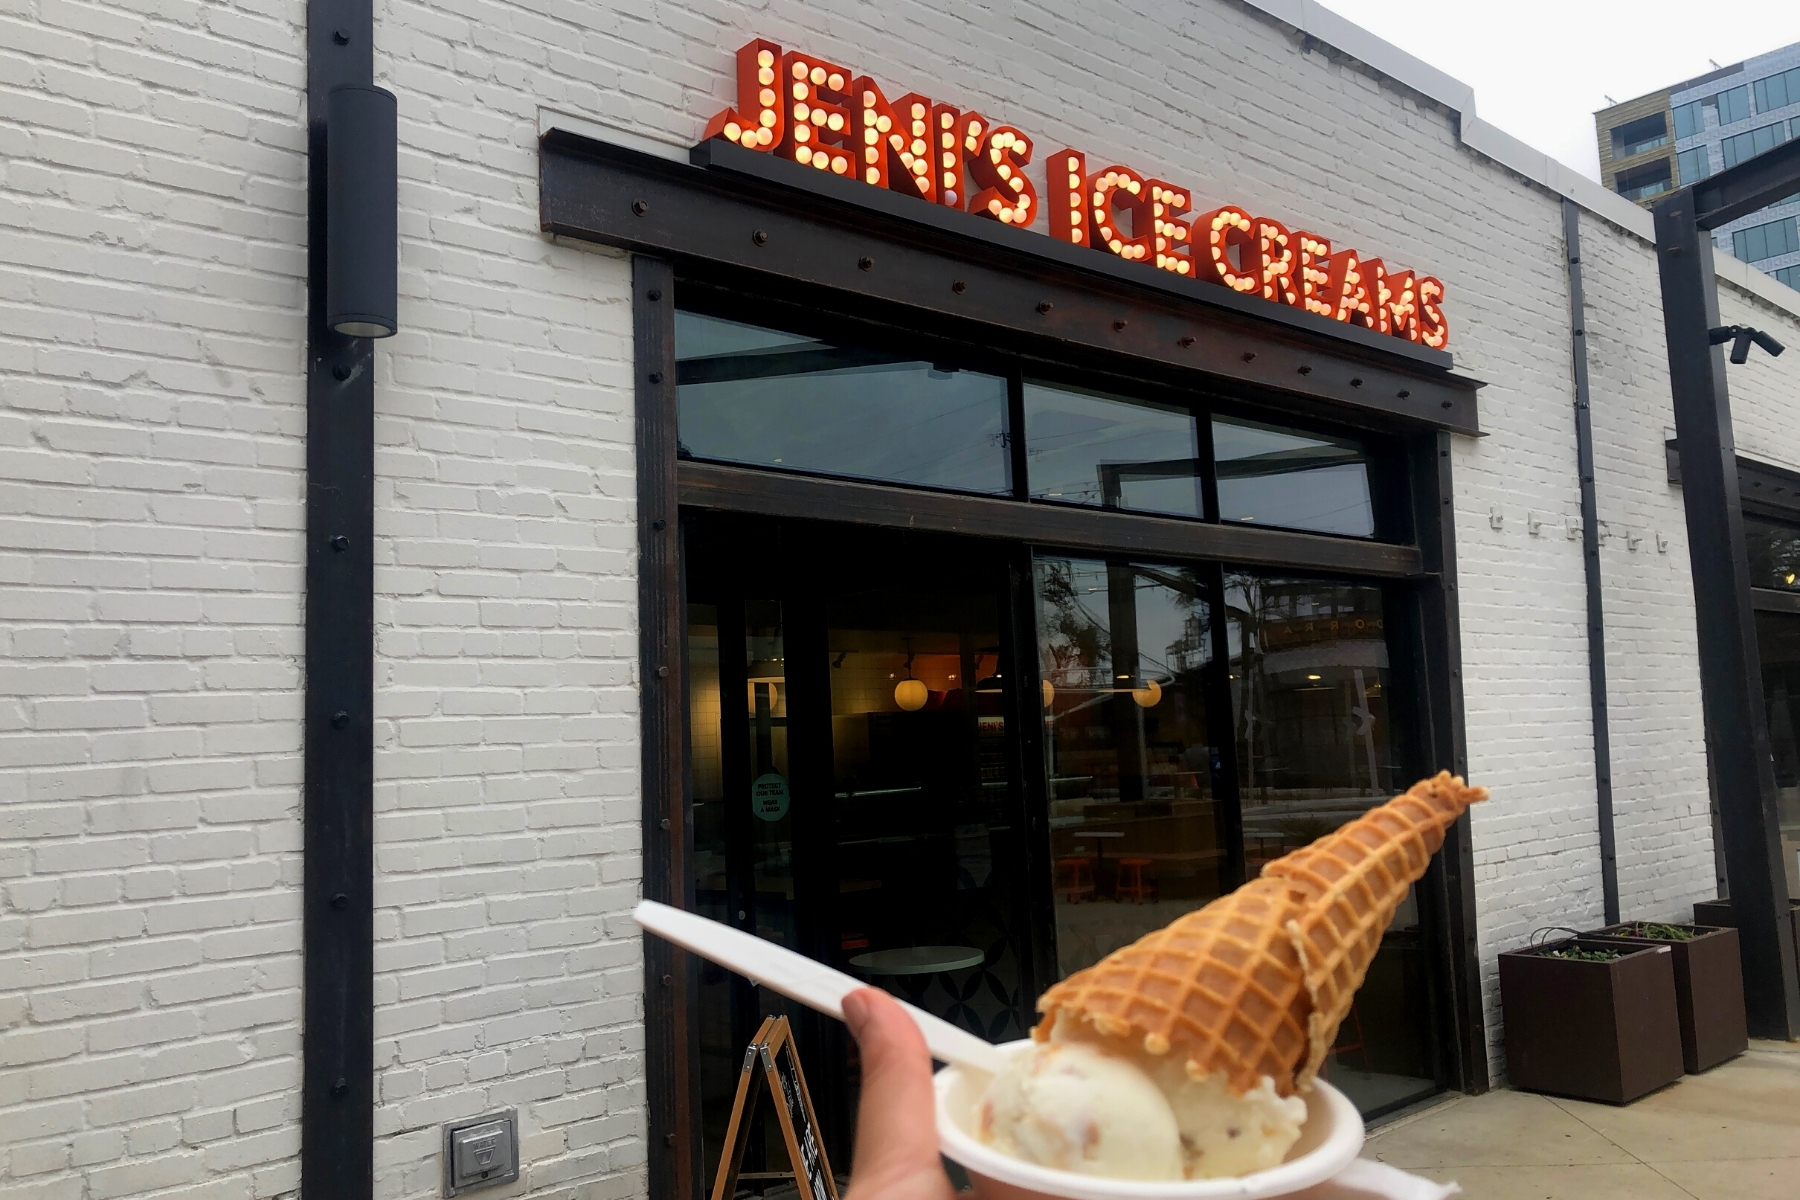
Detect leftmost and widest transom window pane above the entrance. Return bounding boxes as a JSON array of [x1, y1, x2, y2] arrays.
[[675, 311, 1008, 493]]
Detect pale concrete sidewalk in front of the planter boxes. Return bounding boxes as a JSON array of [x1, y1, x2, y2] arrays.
[[1363, 1042, 1800, 1200]]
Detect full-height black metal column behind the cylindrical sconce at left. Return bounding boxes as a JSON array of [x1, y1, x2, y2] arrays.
[[301, 0, 374, 1200]]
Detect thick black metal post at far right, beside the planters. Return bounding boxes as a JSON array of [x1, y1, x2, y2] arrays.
[[1654, 189, 1800, 1038]]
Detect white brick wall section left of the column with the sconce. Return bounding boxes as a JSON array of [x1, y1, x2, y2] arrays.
[[0, 0, 304, 1200]]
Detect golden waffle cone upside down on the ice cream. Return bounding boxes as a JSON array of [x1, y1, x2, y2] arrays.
[[1033, 772, 1487, 1096]]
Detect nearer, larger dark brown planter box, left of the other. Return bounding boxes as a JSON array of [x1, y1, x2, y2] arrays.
[[1499, 939, 1683, 1105]]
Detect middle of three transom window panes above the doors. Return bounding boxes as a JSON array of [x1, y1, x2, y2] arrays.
[[1024, 383, 1204, 516]]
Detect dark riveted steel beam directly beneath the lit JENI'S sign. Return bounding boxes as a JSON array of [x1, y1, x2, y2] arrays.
[[540, 133, 1481, 434]]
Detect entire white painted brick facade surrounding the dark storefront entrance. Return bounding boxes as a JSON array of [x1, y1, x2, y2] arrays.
[[17, 0, 1800, 1200]]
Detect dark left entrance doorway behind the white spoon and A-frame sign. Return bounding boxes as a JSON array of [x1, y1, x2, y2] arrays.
[[686, 516, 1037, 1189]]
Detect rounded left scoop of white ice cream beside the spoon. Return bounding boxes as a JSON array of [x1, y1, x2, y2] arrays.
[[976, 1042, 1184, 1178]]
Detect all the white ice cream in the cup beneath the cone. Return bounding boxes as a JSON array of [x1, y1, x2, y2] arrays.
[[976, 1022, 1307, 1178]]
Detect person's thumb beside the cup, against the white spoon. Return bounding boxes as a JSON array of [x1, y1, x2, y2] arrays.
[[844, 988, 949, 1196]]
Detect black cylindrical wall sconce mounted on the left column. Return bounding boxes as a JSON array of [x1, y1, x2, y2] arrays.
[[326, 85, 400, 338]]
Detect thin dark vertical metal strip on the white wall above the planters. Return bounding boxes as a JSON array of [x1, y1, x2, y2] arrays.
[[1562, 198, 1618, 925]]
